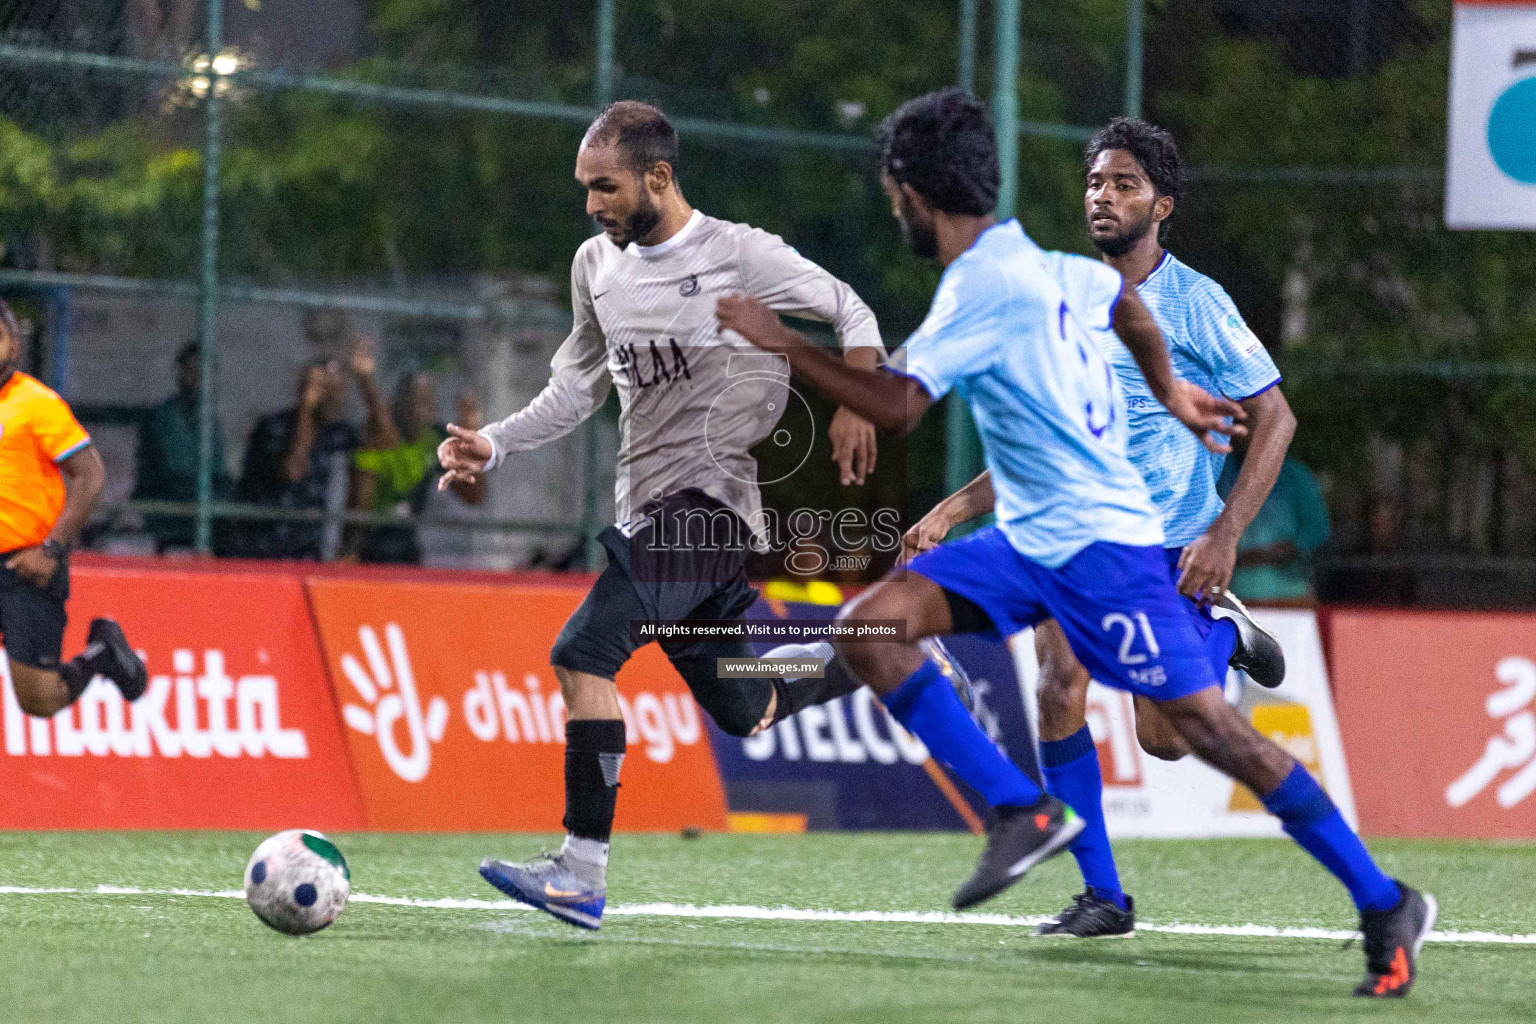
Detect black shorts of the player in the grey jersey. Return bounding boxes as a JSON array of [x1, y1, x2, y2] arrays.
[[550, 488, 773, 735]]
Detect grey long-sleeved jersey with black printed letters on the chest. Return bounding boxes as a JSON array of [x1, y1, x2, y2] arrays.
[[481, 212, 885, 539]]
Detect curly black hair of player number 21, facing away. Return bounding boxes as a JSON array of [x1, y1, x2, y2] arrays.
[[876, 86, 1000, 216]]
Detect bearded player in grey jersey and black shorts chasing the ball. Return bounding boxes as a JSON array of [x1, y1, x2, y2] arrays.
[[438, 101, 903, 929]]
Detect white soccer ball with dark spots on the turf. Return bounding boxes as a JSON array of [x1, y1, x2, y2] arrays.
[[246, 829, 352, 935]]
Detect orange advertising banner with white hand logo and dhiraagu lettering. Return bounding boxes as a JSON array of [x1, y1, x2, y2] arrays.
[[309, 579, 725, 831]]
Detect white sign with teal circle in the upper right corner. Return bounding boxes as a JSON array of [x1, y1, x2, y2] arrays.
[[1445, 0, 1536, 230]]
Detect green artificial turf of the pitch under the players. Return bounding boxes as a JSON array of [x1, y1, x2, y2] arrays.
[[0, 832, 1536, 1024]]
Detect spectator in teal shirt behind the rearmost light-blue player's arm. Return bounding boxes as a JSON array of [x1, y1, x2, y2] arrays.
[[1218, 450, 1329, 600]]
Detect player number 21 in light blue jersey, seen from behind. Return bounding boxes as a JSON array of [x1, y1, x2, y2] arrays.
[[717, 89, 1435, 996]]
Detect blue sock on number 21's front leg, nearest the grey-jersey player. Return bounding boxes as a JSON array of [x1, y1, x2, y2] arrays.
[[882, 662, 1043, 808]]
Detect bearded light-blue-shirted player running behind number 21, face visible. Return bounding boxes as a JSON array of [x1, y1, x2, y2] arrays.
[[908, 118, 1296, 938]]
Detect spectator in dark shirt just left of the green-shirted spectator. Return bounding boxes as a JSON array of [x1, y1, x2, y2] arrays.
[[235, 359, 358, 559]]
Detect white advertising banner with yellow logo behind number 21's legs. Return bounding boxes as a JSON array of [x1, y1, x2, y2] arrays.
[[1012, 608, 1356, 838]]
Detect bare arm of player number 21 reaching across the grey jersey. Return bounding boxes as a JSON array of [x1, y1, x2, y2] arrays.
[[716, 295, 934, 434]]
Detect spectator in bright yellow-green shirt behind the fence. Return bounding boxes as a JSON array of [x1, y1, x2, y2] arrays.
[[352, 339, 485, 565]]
